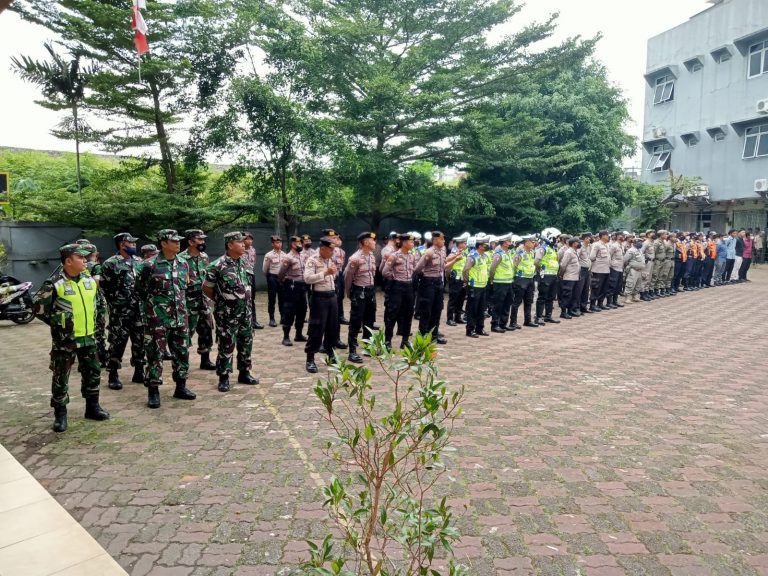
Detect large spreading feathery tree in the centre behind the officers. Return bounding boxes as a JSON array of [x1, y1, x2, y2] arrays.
[[266, 0, 584, 236]]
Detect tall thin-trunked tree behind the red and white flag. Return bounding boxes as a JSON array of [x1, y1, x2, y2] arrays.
[[11, 0, 232, 193]]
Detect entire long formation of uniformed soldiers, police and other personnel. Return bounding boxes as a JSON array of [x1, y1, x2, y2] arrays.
[[36, 228, 752, 432]]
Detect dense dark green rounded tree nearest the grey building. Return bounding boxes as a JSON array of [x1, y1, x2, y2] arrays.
[[461, 60, 634, 232]]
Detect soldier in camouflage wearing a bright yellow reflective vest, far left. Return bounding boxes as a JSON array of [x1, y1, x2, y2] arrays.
[[35, 244, 109, 432]]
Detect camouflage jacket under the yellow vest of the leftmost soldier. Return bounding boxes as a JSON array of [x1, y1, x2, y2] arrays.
[[35, 270, 98, 350]]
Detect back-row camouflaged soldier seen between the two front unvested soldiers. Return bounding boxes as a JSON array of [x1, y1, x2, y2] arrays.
[[179, 230, 216, 370]]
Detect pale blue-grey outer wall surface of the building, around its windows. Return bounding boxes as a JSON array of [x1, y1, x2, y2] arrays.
[[642, 0, 768, 206]]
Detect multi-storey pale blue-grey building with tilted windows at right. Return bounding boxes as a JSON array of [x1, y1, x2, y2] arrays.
[[642, 0, 768, 232]]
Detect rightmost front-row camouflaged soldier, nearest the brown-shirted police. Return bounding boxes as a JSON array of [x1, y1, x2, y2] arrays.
[[203, 232, 259, 392]]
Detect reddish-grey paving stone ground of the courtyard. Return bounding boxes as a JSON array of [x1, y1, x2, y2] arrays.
[[0, 267, 768, 576]]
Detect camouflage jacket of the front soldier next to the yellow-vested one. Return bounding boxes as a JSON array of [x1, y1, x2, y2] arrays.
[[136, 254, 189, 329]]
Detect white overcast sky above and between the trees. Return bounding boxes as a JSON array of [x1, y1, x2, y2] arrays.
[[0, 0, 709, 168]]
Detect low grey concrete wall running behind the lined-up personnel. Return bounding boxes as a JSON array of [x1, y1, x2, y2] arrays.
[[0, 218, 438, 289]]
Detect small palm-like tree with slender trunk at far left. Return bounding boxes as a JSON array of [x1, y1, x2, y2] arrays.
[[11, 43, 96, 197]]
